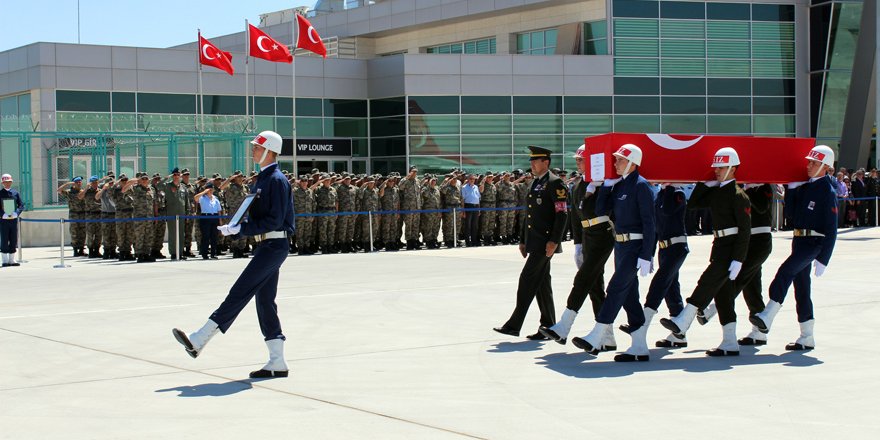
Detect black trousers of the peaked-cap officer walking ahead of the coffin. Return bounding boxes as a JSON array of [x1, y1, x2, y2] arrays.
[[504, 252, 556, 331]]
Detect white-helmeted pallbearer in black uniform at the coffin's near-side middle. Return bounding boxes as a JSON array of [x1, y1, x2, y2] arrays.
[[660, 147, 752, 356]]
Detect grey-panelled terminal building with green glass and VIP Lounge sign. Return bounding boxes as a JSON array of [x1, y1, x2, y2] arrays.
[[0, 0, 877, 208]]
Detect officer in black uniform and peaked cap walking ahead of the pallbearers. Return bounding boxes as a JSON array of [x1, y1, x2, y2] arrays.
[[493, 145, 568, 340]]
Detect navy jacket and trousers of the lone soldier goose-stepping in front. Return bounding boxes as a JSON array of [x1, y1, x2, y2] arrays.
[[210, 163, 294, 341]]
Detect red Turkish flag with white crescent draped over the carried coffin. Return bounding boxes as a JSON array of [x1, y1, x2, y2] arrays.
[[584, 133, 815, 183]]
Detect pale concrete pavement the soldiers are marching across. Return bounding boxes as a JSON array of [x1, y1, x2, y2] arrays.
[[0, 228, 880, 440]]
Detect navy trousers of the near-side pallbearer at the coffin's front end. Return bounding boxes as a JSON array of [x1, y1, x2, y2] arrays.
[[596, 240, 645, 330]]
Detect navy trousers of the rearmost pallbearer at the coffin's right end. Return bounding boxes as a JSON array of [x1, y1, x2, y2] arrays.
[[770, 237, 824, 322]]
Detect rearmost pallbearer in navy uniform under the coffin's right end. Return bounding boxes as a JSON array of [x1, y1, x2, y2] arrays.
[[750, 145, 837, 350]]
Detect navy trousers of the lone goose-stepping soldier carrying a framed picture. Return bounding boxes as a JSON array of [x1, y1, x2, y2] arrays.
[[211, 238, 290, 341]]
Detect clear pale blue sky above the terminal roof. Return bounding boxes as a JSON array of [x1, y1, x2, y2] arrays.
[[0, 0, 315, 52]]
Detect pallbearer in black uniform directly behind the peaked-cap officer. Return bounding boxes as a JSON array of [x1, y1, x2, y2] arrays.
[[540, 145, 617, 351]]
